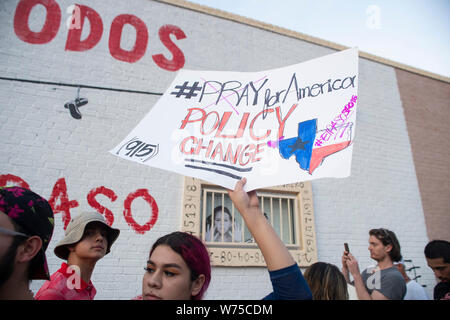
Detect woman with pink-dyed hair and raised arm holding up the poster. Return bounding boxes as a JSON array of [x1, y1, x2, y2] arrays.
[[138, 178, 312, 300]]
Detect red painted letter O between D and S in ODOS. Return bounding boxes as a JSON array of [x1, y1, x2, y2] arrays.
[[109, 14, 148, 63]]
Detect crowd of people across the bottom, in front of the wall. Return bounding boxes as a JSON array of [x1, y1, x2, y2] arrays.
[[0, 182, 450, 300]]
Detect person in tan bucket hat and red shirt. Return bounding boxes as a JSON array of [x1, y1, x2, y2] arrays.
[[35, 212, 120, 300]]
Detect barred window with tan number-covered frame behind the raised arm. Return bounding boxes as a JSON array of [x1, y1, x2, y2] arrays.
[[182, 177, 317, 267]]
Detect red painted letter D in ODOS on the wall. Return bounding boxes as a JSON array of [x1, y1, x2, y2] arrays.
[[66, 4, 103, 51]]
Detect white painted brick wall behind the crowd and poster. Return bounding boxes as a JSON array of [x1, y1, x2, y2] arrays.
[[0, 0, 435, 299]]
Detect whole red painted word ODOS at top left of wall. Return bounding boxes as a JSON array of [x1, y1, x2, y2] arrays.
[[13, 0, 186, 71]]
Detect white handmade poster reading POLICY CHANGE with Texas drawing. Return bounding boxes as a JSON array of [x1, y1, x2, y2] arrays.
[[110, 48, 358, 191]]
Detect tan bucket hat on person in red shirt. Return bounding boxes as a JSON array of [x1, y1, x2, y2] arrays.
[[54, 212, 120, 260]]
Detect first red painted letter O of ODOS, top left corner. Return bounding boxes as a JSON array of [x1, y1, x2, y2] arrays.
[[14, 0, 61, 44]]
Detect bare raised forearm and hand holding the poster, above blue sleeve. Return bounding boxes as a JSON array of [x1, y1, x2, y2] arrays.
[[228, 178, 296, 271]]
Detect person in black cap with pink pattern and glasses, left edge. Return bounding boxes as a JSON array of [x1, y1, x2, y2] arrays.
[[0, 187, 54, 300]]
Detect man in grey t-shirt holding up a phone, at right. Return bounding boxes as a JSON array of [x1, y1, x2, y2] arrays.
[[342, 228, 406, 300]]
